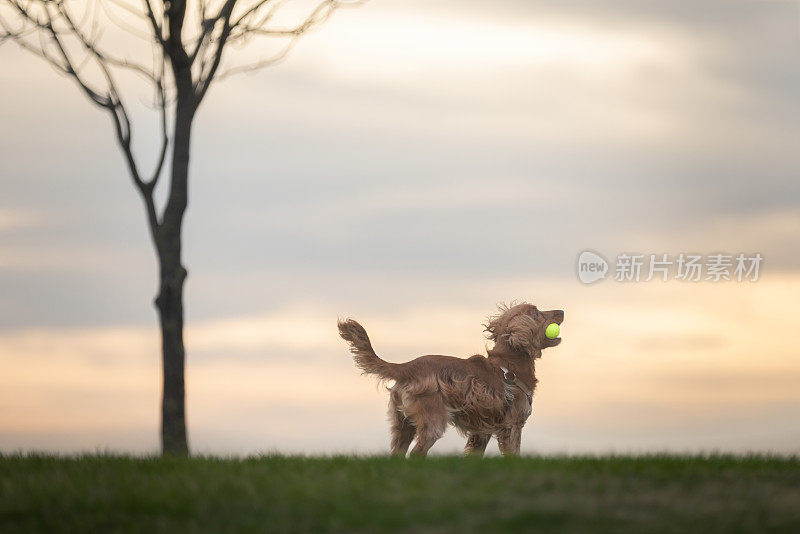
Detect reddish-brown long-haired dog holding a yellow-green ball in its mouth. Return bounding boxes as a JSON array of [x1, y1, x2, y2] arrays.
[[339, 303, 564, 456]]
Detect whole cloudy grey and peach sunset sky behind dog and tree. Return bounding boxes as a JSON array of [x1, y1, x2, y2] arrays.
[[0, 0, 800, 454]]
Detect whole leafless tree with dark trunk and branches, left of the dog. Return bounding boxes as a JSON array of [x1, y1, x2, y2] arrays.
[[0, 0, 359, 455]]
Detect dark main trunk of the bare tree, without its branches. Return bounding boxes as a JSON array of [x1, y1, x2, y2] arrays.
[[155, 84, 196, 456]]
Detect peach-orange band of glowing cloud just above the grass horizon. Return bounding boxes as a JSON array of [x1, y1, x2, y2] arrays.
[[0, 277, 800, 453]]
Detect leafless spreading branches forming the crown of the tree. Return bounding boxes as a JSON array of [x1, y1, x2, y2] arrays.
[[0, 0, 365, 240]]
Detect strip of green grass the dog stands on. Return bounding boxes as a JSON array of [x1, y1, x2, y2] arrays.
[[0, 455, 800, 534]]
